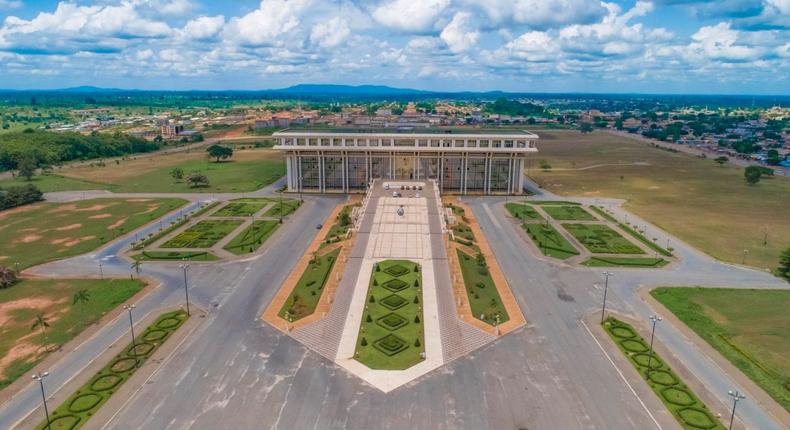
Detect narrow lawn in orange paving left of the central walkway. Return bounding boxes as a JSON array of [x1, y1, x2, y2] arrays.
[[278, 248, 340, 321]]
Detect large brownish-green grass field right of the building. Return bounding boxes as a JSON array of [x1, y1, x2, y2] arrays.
[[529, 130, 790, 268]]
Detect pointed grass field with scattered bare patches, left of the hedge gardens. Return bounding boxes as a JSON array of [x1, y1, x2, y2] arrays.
[[0, 198, 186, 269]]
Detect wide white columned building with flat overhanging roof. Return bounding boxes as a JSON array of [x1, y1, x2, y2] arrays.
[[272, 128, 538, 194]]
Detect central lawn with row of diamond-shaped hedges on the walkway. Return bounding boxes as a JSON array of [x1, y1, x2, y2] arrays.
[[354, 260, 425, 370]]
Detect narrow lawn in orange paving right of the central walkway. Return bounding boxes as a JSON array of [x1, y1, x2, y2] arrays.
[[457, 250, 510, 326]]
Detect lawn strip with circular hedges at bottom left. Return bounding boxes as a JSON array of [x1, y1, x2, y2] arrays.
[[36, 310, 189, 430]]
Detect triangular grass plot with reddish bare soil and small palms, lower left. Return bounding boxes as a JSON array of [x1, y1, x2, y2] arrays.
[[0, 279, 145, 388]]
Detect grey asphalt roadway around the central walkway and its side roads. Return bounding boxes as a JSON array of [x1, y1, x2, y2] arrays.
[[0, 182, 786, 429]]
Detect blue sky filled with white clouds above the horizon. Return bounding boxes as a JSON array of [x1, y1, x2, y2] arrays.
[[0, 0, 790, 95]]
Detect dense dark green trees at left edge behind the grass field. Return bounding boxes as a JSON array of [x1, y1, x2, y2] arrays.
[[0, 129, 161, 171]]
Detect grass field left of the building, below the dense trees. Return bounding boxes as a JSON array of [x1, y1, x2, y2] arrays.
[[0, 149, 285, 193]]
